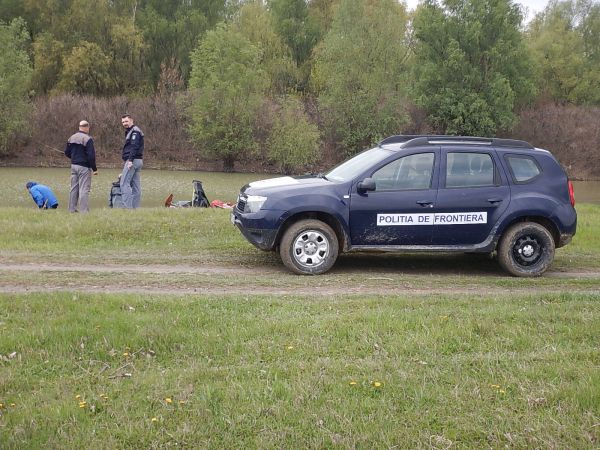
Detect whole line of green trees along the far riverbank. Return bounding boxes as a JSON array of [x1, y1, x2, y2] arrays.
[[0, 0, 600, 173]]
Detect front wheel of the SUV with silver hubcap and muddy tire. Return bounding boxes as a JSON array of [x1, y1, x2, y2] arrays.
[[279, 219, 339, 275]]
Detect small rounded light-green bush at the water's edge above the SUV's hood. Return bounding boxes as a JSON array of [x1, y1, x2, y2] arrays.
[[267, 96, 320, 174]]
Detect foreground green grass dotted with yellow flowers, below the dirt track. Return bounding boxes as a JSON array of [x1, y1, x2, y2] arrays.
[[0, 294, 600, 448]]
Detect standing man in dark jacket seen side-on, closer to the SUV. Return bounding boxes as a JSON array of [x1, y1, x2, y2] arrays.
[[121, 114, 144, 209]]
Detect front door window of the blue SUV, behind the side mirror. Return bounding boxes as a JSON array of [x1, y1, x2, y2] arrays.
[[372, 153, 435, 191]]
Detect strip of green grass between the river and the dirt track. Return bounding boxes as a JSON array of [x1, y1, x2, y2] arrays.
[[0, 204, 600, 273]]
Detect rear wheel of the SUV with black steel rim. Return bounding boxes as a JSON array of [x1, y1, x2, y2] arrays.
[[498, 222, 555, 277]]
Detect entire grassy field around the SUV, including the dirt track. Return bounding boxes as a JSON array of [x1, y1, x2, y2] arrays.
[[0, 168, 600, 449]]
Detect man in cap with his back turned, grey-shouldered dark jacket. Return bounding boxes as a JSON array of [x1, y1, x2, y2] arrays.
[[65, 120, 98, 212]]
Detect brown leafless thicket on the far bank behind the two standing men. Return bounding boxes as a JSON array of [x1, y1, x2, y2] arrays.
[[7, 94, 197, 169]]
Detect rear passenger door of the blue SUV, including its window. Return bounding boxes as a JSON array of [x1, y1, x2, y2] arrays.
[[432, 146, 510, 246]]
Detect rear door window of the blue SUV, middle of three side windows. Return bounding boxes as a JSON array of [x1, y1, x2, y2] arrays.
[[446, 152, 496, 188]]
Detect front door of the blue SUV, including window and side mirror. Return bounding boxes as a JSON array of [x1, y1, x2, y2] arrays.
[[350, 147, 439, 246]]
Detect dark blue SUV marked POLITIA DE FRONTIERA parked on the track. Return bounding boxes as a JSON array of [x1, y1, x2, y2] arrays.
[[231, 135, 577, 276]]
